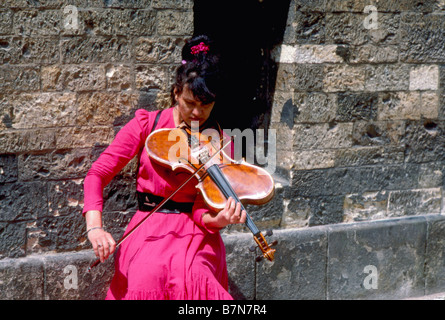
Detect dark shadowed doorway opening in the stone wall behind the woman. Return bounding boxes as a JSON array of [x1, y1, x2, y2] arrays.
[[194, 0, 290, 130]]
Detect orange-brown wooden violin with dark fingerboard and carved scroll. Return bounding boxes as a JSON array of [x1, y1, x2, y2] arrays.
[[145, 124, 276, 261]]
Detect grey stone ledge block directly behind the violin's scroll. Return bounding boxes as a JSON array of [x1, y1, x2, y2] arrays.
[[256, 228, 328, 300]]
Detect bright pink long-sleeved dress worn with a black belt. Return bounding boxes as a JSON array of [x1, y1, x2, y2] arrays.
[[83, 108, 232, 300]]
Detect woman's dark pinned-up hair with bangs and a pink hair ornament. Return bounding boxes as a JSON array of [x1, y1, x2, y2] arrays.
[[171, 35, 221, 104]]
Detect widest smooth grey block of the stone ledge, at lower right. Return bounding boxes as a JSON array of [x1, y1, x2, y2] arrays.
[[327, 217, 427, 300]]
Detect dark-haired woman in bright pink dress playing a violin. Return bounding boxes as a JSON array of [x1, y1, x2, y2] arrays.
[[83, 36, 246, 300]]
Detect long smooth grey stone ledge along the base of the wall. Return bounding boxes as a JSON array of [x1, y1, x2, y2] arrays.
[[0, 215, 445, 300]]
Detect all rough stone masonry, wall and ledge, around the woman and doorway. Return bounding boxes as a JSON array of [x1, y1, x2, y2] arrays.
[[0, 0, 445, 299]]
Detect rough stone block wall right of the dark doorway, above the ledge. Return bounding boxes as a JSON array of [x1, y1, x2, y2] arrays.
[[271, 0, 445, 227]]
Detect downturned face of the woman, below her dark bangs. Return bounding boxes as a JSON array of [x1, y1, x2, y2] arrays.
[[174, 85, 215, 126]]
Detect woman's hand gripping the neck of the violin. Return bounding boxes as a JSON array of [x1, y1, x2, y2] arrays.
[[203, 197, 247, 228]]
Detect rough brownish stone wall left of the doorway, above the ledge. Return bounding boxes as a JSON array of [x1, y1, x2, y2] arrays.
[[0, 0, 193, 258]]
